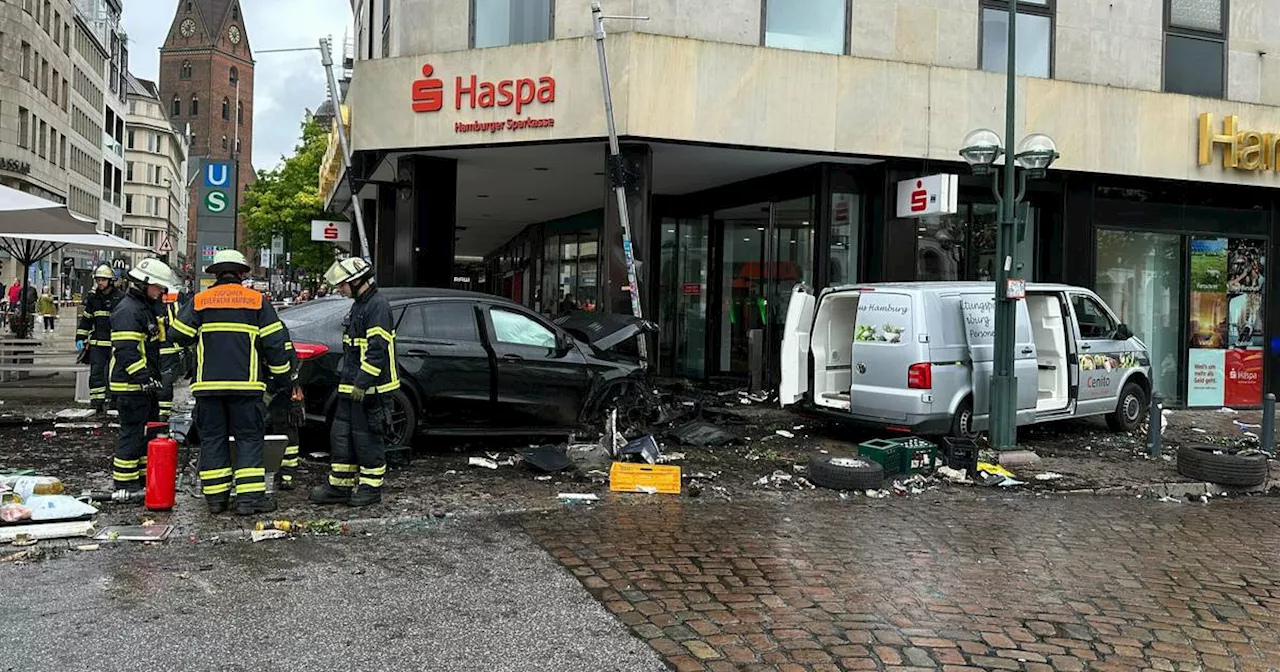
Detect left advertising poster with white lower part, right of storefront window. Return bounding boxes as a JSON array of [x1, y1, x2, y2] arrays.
[[1187, 238, 1231, 406]]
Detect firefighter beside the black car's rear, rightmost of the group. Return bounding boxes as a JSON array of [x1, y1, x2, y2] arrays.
[[311, 257, 399, 507]]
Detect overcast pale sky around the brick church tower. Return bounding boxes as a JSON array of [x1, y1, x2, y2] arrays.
[[124, 0, 352, 170]]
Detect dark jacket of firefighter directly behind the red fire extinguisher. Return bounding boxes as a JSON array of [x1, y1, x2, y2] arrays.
[[109, 288, 160, 394]]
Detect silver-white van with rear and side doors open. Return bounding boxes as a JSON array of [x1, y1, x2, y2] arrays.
[[778, 282, 1151, 435]]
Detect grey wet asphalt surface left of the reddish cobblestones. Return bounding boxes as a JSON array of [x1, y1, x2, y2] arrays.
[[0, 520, 666, 672]]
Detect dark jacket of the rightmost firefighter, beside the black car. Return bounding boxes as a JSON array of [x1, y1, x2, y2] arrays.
[[338, 287, 399, 397]]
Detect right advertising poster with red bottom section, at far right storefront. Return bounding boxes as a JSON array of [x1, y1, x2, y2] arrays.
[[1224, 238, 1266, 406]]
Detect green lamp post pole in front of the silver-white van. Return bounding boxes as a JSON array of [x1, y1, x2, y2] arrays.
[[991, 0, 1018, 451]]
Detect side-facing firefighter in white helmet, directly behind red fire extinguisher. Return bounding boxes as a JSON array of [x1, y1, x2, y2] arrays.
[[108, 259, 177, 490]]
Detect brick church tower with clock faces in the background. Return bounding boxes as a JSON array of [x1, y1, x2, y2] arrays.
[[160, 0, 255, 275]]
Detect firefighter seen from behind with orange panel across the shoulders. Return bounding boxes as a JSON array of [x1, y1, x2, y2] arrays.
[[173, 250, 292, 516]]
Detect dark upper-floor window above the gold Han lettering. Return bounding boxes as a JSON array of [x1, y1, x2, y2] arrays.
[[1165, 0, 1226, 99]]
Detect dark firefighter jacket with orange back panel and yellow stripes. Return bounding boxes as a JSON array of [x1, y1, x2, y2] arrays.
[[173, 279, 291, 397]]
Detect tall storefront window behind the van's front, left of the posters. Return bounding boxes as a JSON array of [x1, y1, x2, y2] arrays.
[[1094, 229, 1194, 403]]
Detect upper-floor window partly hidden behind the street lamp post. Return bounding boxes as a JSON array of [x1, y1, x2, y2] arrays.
[[982, 0, 1056, 77]]
